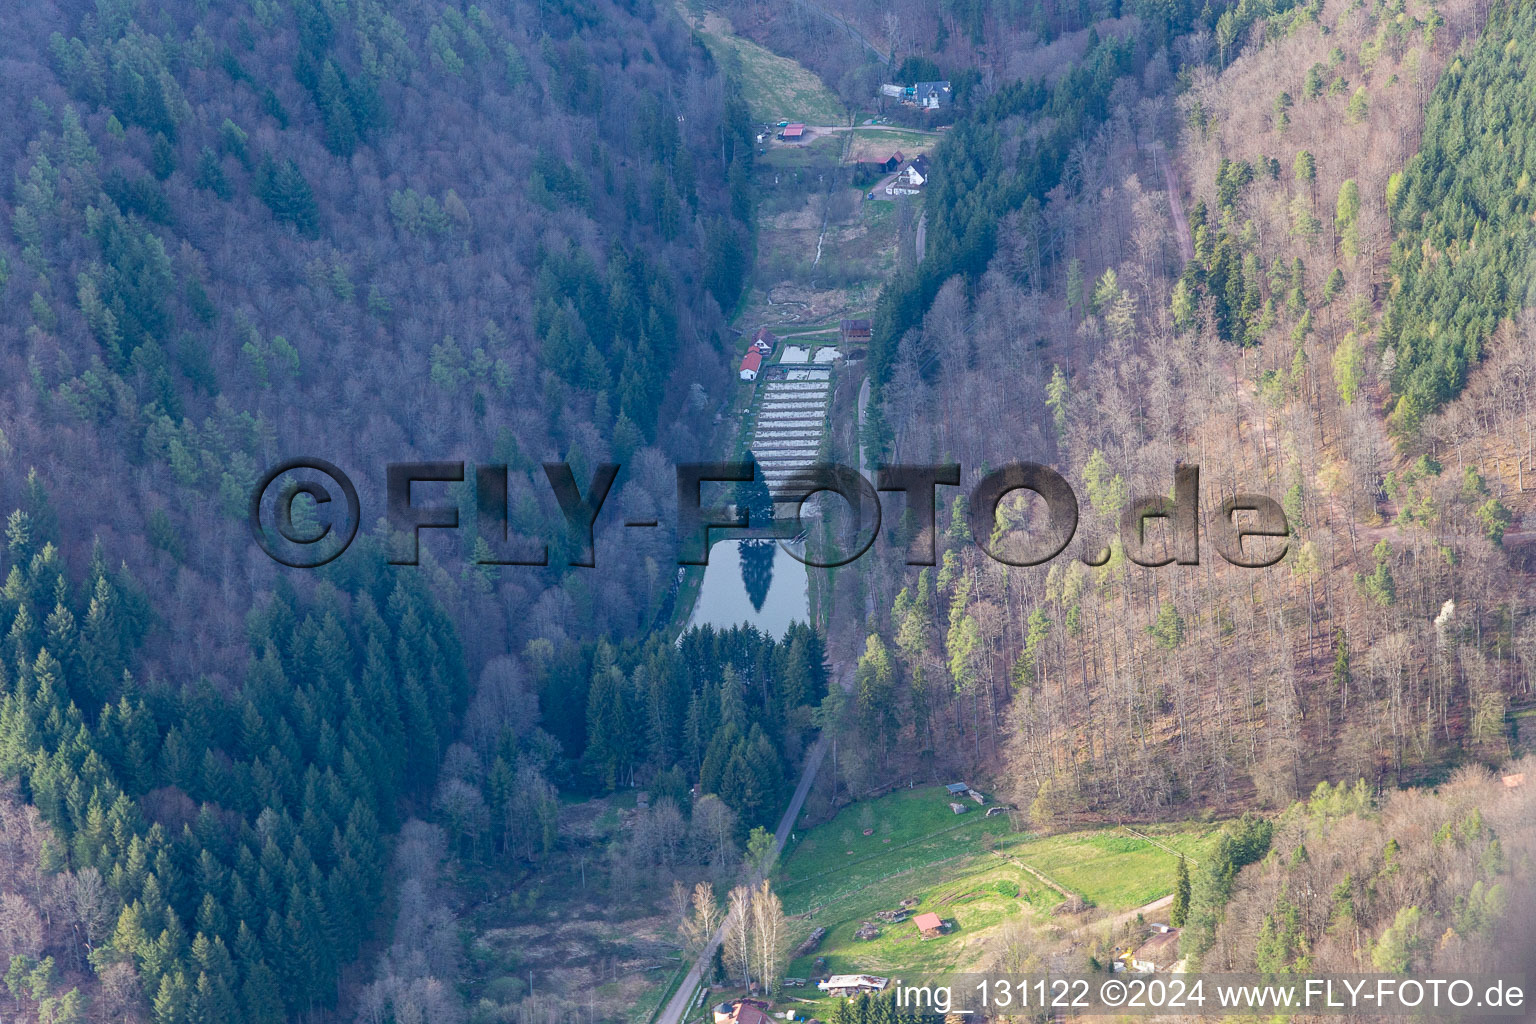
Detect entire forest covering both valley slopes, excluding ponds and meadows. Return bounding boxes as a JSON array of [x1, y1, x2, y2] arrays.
[[0, 0, 1536, 1024]]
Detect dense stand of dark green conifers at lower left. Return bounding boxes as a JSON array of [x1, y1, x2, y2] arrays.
[[0, 515, 467, 1022]]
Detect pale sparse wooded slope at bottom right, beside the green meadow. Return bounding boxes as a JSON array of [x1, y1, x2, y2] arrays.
[[1181, 765, 1531, 975]]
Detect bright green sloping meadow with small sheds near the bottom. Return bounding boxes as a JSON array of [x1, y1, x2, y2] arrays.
[[774, 786, 1221, 1019]]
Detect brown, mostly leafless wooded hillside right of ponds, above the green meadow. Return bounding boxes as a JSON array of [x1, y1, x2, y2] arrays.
[[804, 3, 1536, 823]]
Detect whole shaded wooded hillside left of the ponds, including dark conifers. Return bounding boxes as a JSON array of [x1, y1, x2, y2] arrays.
[[0, 0, 764, 1024]]
